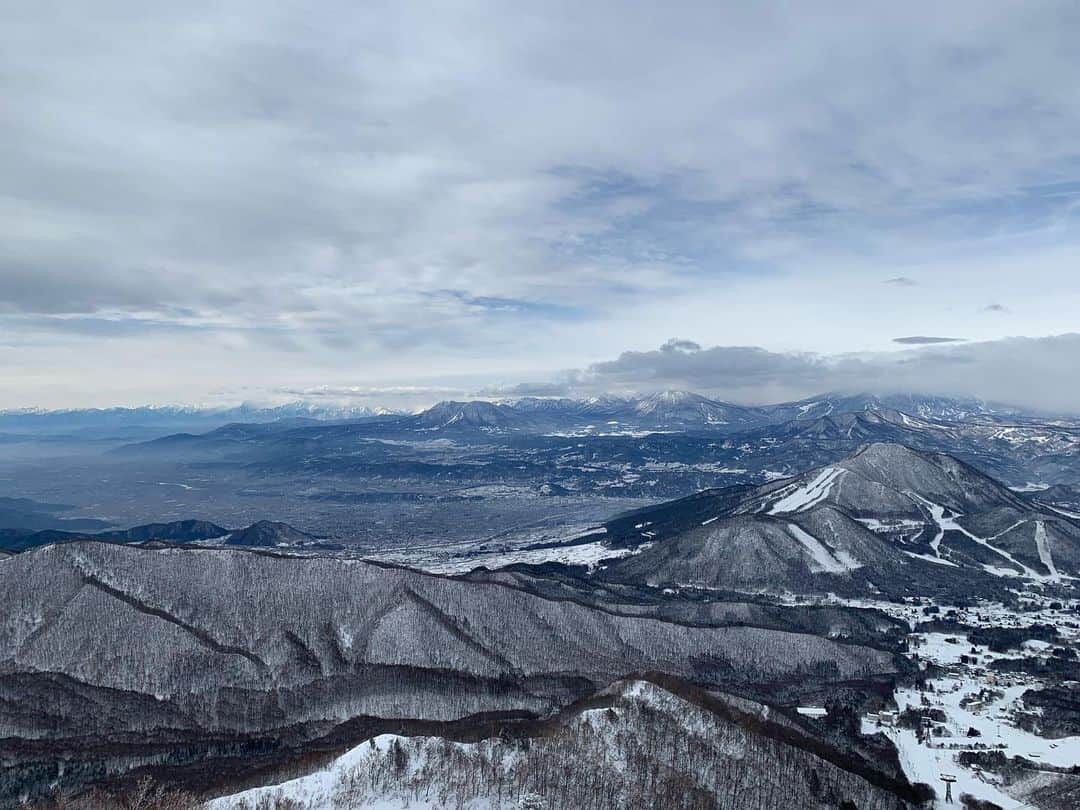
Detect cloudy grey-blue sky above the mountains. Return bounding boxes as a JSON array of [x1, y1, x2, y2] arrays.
[[0, 0, 1080, 413]]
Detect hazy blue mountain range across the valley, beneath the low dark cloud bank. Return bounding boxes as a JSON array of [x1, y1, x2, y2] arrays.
[[113, 392, 1080, 499]]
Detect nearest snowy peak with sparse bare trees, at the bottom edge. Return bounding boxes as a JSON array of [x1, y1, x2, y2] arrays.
[[207, 678, 924, 810]]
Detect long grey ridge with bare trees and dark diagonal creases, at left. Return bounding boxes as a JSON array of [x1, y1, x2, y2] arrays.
[[0, 542, 903, 804]]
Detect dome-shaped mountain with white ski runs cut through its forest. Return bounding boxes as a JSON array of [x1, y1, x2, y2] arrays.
[[606, 444, 1080, 595]]
